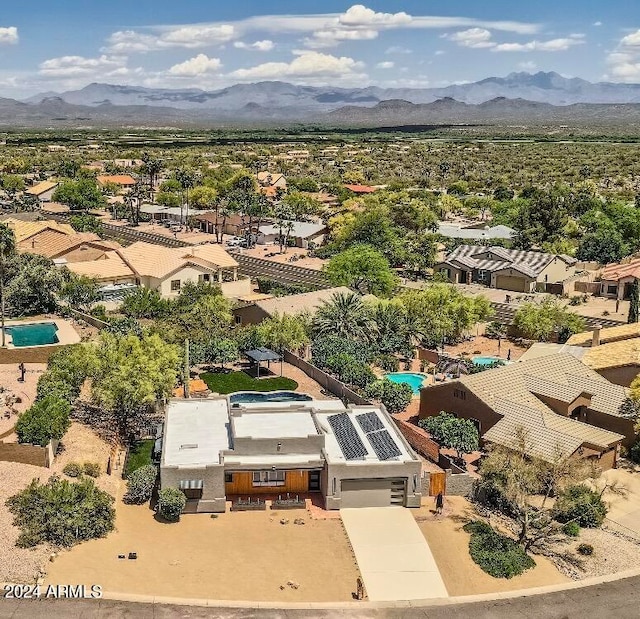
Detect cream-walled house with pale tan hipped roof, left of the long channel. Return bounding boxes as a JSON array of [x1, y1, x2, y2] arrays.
[[68, 241, 252, 298]]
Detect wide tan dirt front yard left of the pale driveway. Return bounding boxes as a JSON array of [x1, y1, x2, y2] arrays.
[[46, 503, 359, 602]]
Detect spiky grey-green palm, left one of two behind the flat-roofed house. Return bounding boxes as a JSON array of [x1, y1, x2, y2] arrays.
[[313, 292, 372, 340]]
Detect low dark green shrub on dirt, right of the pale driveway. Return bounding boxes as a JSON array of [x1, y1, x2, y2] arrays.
[[464, 521, 536, 578]]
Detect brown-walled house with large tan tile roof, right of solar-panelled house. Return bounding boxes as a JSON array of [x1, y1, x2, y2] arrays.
[[420, 354, 635, 469]]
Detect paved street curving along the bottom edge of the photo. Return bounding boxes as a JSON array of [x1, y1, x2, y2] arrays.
[[0, 576, 640, 619]]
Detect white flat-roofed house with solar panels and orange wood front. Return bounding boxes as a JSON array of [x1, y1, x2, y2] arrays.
[[160, 397, 422, 512]]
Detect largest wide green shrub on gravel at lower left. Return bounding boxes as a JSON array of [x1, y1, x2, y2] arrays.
[[7, 476, 115, 548]]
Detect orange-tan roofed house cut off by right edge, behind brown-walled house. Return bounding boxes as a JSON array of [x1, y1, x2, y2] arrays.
[[567, 322, 640, 387]]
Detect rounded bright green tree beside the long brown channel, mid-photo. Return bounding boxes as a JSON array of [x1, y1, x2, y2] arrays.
[[325, 245, 398, 297]]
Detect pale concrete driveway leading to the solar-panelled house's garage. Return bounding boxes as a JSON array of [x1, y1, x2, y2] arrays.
[[340, 507, 448, 602]]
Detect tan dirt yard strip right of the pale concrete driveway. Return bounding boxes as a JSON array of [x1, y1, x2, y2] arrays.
[[414, 497, 569, 596]]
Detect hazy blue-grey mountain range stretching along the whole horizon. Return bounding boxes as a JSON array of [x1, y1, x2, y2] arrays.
[[0, 72, 640, 126]]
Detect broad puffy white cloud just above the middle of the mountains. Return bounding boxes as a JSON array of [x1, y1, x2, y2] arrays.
[[228, 51, 366, 81]]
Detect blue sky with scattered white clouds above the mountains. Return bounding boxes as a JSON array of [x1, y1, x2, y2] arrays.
[[0, 0, 640, 97]]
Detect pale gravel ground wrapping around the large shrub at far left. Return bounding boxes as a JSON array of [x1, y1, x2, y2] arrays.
[[0, 423, 120, 583]]
